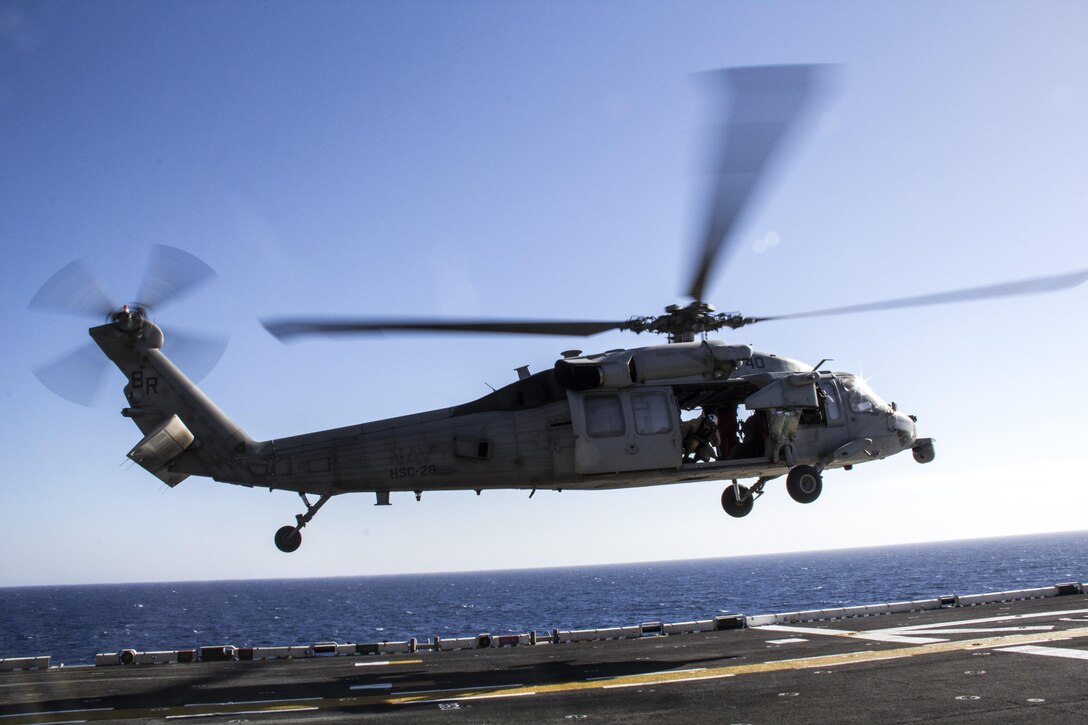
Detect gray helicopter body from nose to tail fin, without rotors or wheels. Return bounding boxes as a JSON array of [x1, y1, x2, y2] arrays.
[[90, 321, 931, 511]]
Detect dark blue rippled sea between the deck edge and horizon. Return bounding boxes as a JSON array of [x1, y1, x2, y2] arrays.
[[0, 531, 1088, 665]]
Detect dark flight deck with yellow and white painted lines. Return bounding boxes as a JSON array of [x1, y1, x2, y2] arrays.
[[0, 585, 1088, 725]]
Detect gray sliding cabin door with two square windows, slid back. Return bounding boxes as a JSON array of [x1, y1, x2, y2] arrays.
[[567, 386, 681, 474]]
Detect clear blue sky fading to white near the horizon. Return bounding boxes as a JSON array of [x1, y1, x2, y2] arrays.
[[0, 0, 1088, 586]]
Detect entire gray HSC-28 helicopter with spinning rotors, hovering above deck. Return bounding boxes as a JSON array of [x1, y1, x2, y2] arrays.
[[30, 65, 1088, 552]]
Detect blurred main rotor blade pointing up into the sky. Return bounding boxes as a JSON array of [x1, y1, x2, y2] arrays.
[[688, 65, 827, 302]]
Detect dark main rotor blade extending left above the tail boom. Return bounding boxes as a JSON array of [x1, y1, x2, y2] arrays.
[[261, 318, 627, 340]]
